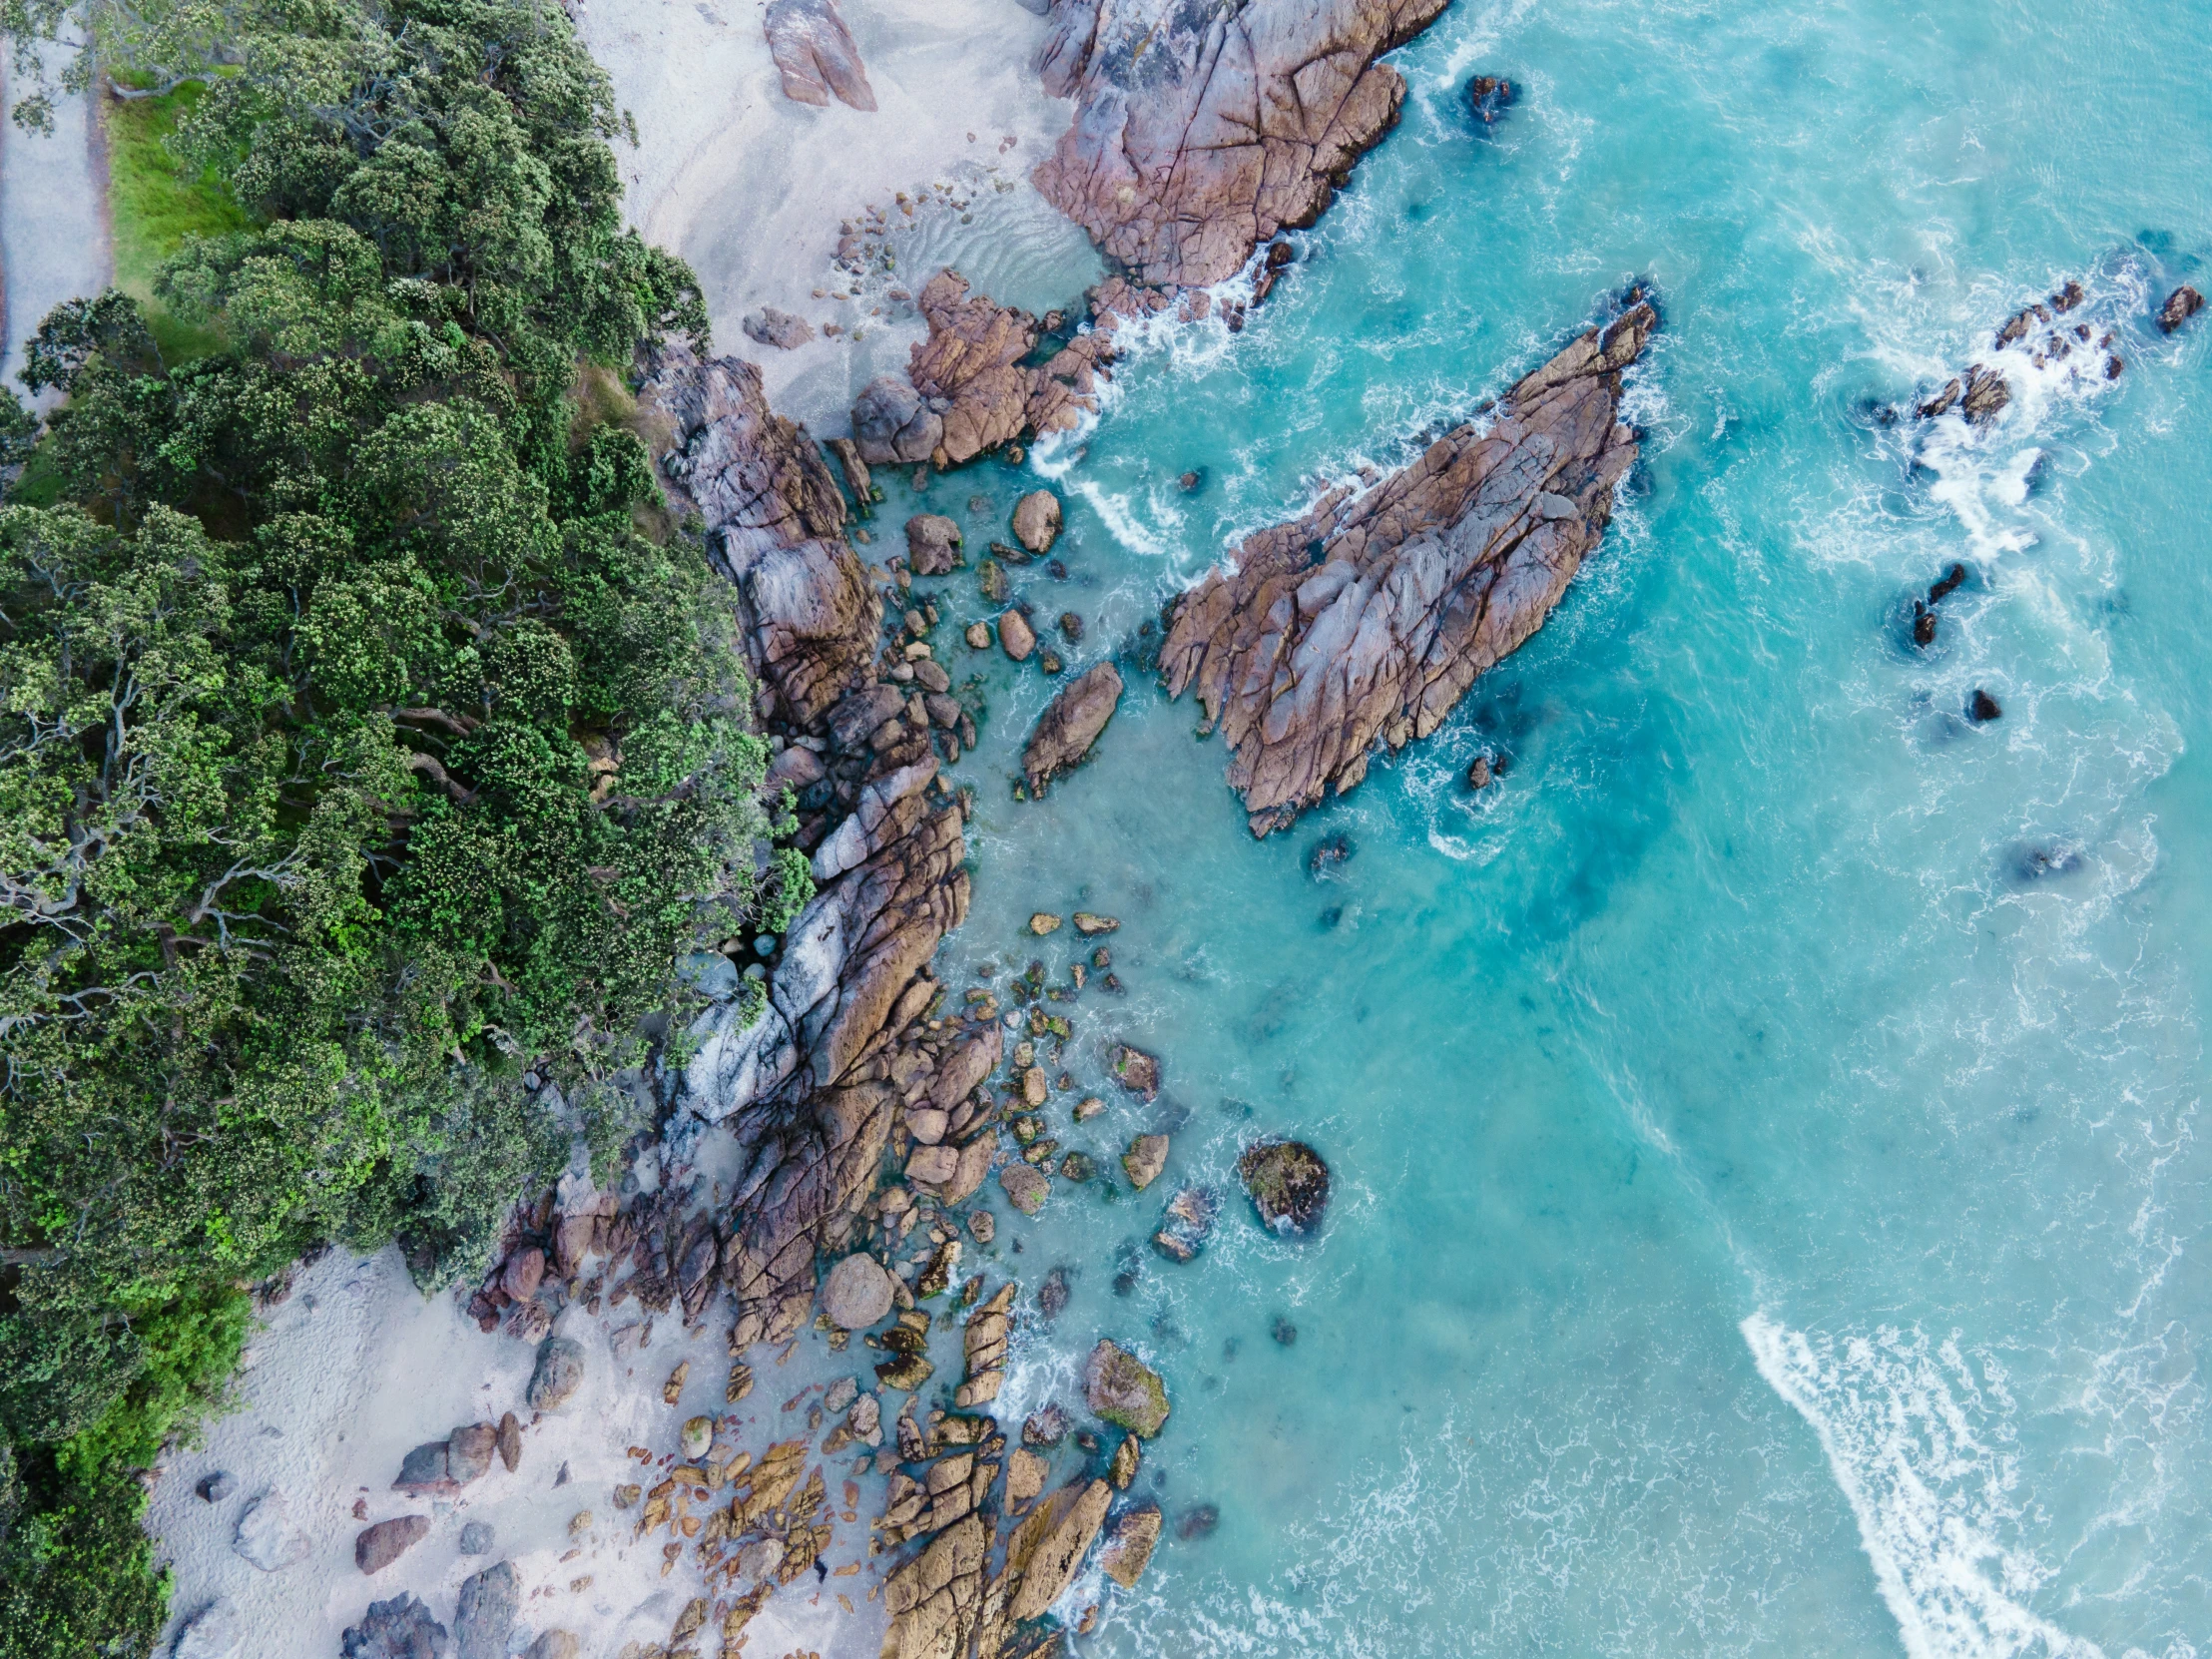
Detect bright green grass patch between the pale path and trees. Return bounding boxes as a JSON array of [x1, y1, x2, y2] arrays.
[[109, 82, 253, 365]]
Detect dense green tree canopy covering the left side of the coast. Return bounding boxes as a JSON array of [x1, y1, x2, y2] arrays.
[[0, 0, 779, 1659]]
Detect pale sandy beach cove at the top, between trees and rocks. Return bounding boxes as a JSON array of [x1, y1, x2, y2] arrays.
[[577, 0, 1102, 436]]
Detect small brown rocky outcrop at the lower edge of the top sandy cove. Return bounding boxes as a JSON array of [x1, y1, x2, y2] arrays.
[[851, 270, 1113, 469]]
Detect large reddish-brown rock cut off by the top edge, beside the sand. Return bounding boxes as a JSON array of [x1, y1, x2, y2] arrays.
[[1033, 0, 1444, 285]]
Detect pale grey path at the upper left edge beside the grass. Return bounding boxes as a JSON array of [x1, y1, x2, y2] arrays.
[[0, 78, 115, 406]]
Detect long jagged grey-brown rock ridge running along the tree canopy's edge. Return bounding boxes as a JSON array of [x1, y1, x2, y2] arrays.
[[644, 351, 1002, 1350]]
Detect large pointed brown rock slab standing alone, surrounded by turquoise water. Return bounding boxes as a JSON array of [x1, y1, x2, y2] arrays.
[[1159, 303, 1657, 836]]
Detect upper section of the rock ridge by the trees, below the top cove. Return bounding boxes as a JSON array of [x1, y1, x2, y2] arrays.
[[639, 344, 882, 728]]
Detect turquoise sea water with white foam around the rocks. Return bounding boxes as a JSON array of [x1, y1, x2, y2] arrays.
[[882, 0, 2212, 1657]]
